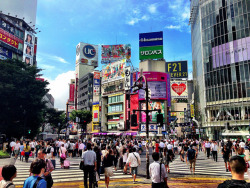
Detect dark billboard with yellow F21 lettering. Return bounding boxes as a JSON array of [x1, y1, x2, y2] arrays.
[[166, 61, 188, 78]]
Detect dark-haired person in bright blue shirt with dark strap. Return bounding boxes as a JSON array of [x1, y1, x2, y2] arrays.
[[23, 159, 47, 188]]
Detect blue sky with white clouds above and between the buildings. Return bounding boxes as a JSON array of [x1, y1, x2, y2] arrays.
[[36, 0, 192, 109]]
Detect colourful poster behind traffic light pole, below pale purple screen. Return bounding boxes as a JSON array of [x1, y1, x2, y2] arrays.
[[141, 101, 165, 123]]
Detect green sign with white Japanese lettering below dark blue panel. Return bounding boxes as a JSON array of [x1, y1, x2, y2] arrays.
[[139, 46, 163, 60]]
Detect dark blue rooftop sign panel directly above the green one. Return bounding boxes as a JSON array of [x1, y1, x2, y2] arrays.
[[139, 31, 163, 47]]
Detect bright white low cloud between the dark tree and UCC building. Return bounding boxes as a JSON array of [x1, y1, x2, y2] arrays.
[[45, 71, 75, 110]]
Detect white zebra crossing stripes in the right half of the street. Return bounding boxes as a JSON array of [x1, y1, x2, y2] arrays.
[[170, 152, 248, 178]]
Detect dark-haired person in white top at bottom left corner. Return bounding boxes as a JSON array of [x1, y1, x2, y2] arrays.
[[0, 165, 17, 188]]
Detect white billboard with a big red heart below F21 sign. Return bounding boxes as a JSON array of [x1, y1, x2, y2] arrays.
[[171, 81, 188, 99]]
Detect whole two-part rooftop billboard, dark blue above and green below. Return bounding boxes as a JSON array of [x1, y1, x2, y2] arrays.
[[139, 31, 163, 60]]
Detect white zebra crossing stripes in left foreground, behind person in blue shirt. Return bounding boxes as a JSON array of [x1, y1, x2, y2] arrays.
[[9, 159, 132, 185]]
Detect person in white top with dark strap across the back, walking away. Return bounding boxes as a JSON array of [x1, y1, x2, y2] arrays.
[[126, 148, 141, 183]]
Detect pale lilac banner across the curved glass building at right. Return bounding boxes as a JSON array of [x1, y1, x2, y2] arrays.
[[212, 37, 250, 68]]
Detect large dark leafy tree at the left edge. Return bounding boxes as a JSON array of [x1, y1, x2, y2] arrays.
[[0, 59, 49, 138]]
